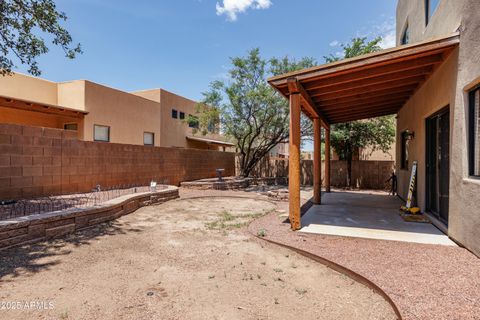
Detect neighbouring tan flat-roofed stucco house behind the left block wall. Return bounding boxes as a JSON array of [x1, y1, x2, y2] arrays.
[[0, 73, 233, 151]]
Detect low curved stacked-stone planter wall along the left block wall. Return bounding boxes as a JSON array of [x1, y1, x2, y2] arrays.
[[0, 186, 179, 251]]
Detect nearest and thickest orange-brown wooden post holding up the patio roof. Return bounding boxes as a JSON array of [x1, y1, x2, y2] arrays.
[[288, 92, 301, 230]]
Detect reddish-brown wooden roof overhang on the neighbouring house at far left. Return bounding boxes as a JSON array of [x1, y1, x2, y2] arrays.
[[0, 96, 88, 118]]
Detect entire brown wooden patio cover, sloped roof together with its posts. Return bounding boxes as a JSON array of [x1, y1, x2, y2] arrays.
[[268, 34, 459, 230]]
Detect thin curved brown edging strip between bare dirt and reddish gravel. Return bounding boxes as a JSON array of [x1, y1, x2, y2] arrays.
[[248, 229, 403, 320]]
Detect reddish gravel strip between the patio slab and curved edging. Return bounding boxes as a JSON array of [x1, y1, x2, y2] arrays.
[[249, 199, 480, 320]]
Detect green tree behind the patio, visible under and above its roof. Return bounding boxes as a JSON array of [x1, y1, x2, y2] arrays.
[[325, 37, 395, 187]]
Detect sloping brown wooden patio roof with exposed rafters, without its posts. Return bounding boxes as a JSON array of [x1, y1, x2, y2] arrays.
[[268, 33, 460, 125]]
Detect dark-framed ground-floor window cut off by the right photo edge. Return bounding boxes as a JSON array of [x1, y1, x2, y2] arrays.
[[469, 86, 480, 177]]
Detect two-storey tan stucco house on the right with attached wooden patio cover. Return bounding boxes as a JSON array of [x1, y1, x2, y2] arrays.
[[269, 0, 480, 255]]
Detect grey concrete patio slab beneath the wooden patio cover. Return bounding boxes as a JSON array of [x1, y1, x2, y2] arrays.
[[301, 192, 456, 246]]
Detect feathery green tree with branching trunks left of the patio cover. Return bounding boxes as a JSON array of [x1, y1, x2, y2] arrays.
[[199, 48, 315, 177]]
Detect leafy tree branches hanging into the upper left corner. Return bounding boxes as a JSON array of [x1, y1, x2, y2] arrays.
[[0, 0, 82, 76]]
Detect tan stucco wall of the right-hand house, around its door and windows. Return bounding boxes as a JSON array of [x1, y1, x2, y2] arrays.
[[397, 0, 480, 255]]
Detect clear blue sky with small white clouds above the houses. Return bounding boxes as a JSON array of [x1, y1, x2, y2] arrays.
[[17, 0, 396, 99]]
